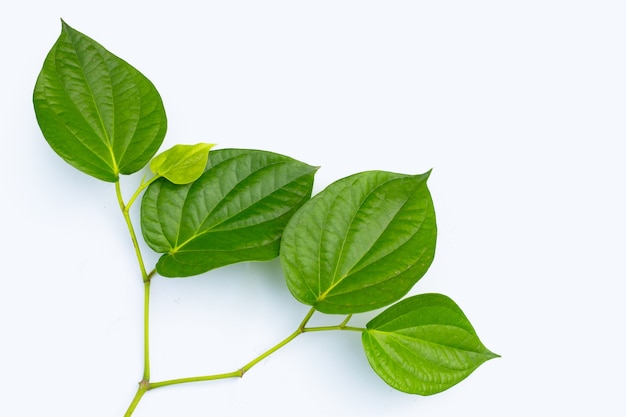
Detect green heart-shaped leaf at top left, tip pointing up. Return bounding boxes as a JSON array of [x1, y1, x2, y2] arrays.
[[33, 22, 167, 182]]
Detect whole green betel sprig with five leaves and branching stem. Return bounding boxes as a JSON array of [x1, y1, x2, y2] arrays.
[[33, 22, 498, 417]]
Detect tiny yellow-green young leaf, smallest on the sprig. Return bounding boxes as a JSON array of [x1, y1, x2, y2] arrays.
[[150, 143, 214, 184]]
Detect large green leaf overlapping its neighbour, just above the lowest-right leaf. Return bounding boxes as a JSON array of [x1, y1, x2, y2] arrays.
[[281, 171, 437, 314]]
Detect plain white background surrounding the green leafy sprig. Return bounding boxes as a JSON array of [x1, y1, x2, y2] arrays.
[[0, 0, 626, 417]]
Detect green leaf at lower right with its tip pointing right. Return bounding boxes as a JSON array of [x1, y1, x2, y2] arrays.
[[362, 294, 498, 395]]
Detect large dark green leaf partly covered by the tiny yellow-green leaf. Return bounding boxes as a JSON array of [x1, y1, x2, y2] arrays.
[[141, 149, 317, 277]]
